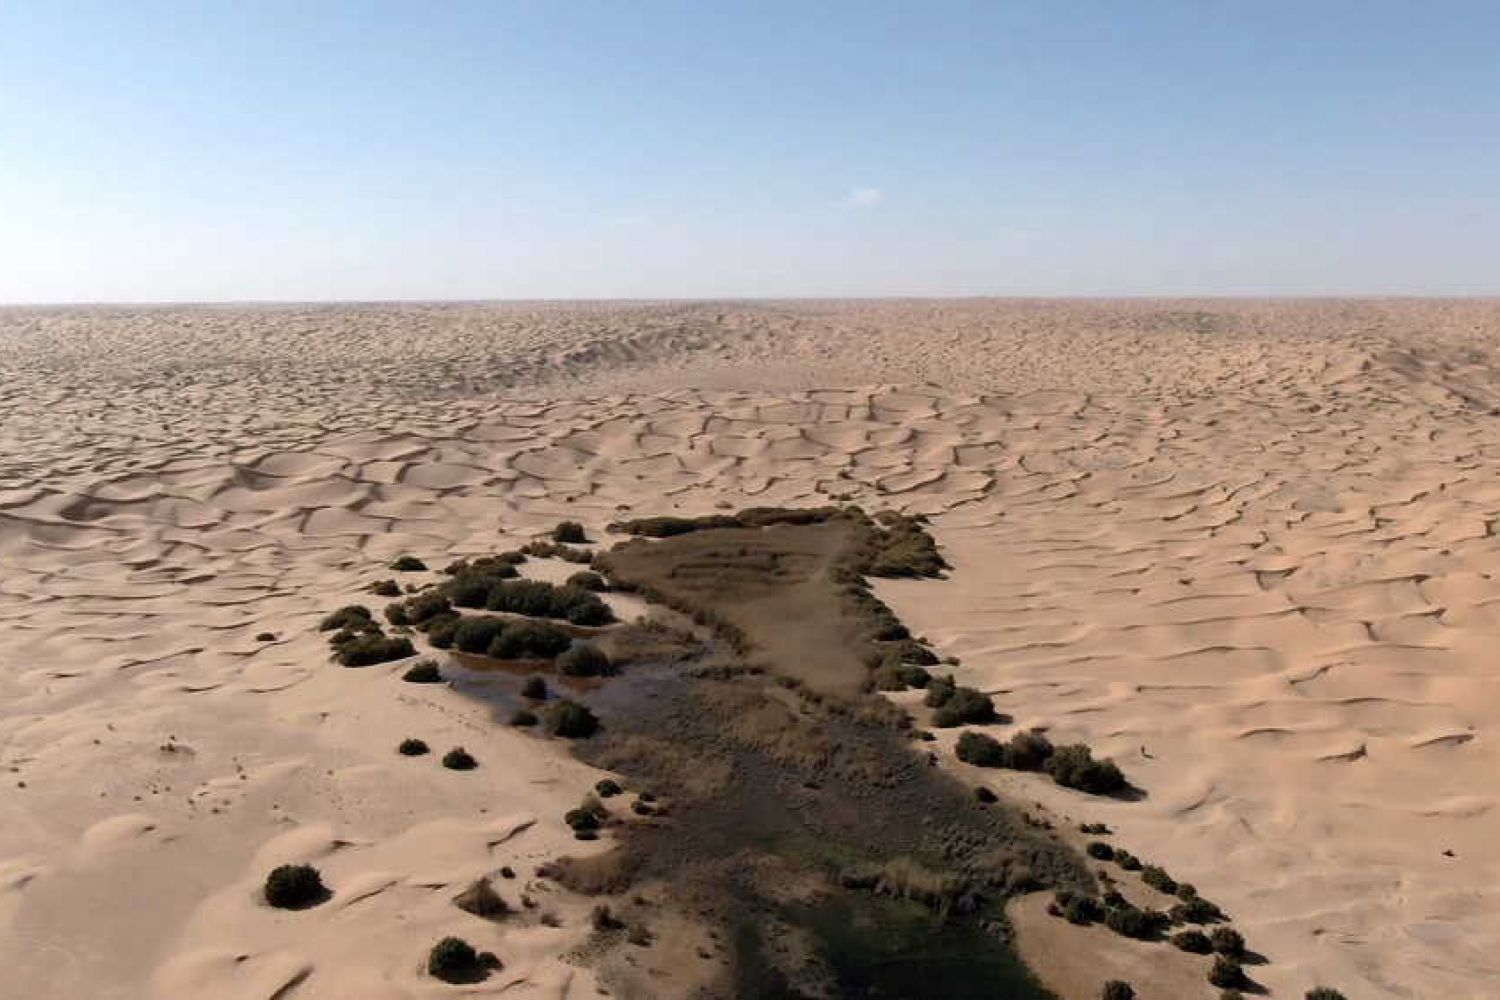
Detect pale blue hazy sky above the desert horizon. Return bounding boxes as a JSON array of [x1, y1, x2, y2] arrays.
[[0, 0, 1500, 301]]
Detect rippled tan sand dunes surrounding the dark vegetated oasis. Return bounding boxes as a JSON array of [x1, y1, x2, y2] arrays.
[[0, 300, 1500, 1000]]
